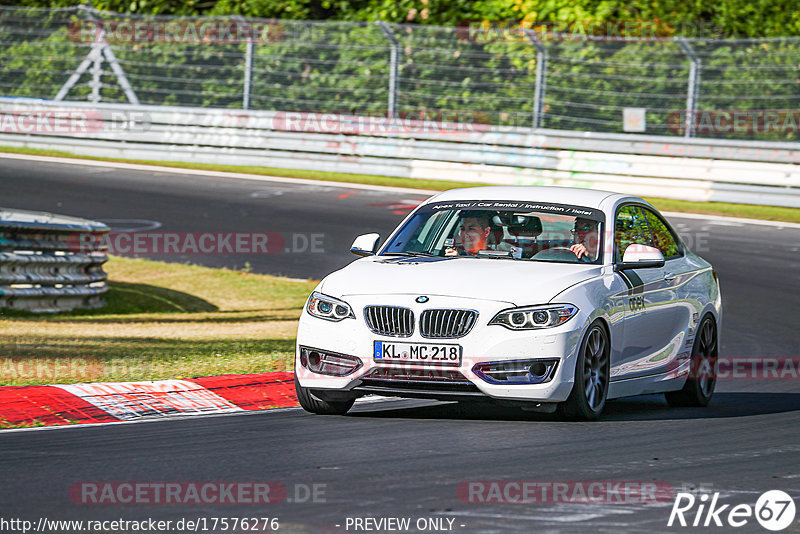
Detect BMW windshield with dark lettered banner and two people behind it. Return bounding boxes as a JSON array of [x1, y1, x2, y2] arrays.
[[381, 201, 603, 263]]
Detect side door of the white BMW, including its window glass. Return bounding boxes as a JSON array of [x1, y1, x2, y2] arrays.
[[611, 204, 682, 380]]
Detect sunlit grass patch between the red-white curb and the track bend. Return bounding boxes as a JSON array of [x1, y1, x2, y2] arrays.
[[0, 257, 316, 385]]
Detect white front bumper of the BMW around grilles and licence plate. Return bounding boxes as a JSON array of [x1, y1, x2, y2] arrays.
[[295, 295, 585, 403]]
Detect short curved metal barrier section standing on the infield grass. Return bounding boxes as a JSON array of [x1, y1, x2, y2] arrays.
[[0, 209, 109, 312]]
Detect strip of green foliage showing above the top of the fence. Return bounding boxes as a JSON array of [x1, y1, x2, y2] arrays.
[[0, 0, 800, 37]]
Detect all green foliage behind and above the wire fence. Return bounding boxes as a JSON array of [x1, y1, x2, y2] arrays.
[[0, 0, 800, 140]]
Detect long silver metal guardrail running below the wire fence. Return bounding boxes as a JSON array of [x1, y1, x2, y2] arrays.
[[0, 98, 800, 207]]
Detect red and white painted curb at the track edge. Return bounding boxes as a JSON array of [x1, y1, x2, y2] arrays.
[[0, 372, 298, 426]]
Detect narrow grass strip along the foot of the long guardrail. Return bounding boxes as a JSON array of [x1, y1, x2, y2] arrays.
[[0, 147, 800, 223]]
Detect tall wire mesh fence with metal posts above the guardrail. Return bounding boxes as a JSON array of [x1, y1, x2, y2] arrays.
[[0, 6, 800, 141]]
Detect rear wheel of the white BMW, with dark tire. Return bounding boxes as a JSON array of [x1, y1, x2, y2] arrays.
[[664, 315, 719, 407]]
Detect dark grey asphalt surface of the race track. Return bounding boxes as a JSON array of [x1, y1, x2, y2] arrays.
[[0, 158, 800, 533]]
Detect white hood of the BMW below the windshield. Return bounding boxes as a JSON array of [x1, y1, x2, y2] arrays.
[[320, 256, 602, 306]]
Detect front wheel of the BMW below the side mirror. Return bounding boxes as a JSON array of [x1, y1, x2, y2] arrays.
[[558, 321, 611, 421]]
